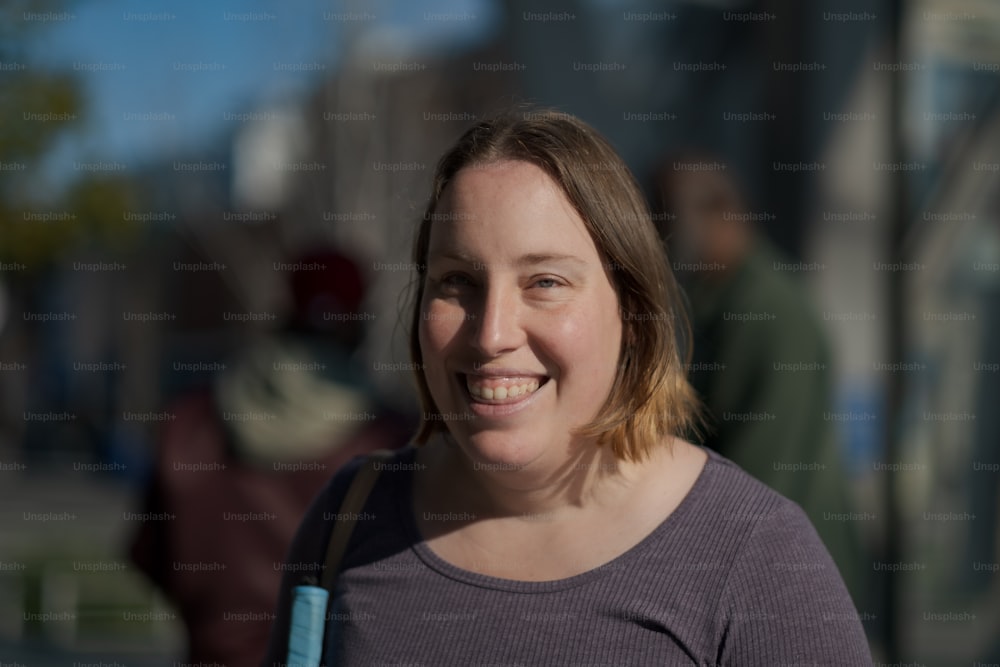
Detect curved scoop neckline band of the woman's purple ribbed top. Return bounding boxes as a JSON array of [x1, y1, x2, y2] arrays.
[[392, 445, 726, 593]]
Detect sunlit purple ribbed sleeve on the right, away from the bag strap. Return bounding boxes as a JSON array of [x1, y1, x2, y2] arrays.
[[718, 499, 872, 667]]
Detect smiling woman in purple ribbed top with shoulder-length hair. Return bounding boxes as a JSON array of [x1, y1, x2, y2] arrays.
[[265, 112, 870, 665]]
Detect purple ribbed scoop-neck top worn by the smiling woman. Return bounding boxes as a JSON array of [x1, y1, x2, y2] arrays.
[[263, 449, 871, 667]]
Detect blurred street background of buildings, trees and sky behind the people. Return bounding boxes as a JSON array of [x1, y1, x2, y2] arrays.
[[0, 0, 1000, 667]]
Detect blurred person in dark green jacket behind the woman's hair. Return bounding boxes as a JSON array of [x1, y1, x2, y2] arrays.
[[654, 155, 868, 609]]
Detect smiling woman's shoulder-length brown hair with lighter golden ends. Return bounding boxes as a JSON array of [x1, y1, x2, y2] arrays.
[[410, 110, 698, 460]]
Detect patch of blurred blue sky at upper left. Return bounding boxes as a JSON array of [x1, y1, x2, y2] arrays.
[[32, 0, 496, 177]]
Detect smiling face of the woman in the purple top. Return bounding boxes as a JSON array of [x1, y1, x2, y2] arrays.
[[419, 161, 622, 470]]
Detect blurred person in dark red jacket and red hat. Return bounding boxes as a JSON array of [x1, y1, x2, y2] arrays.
[[131, 250, 412, 666]]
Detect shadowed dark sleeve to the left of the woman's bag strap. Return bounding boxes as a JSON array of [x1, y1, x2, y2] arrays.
[[260, 456, 364, 667]]
